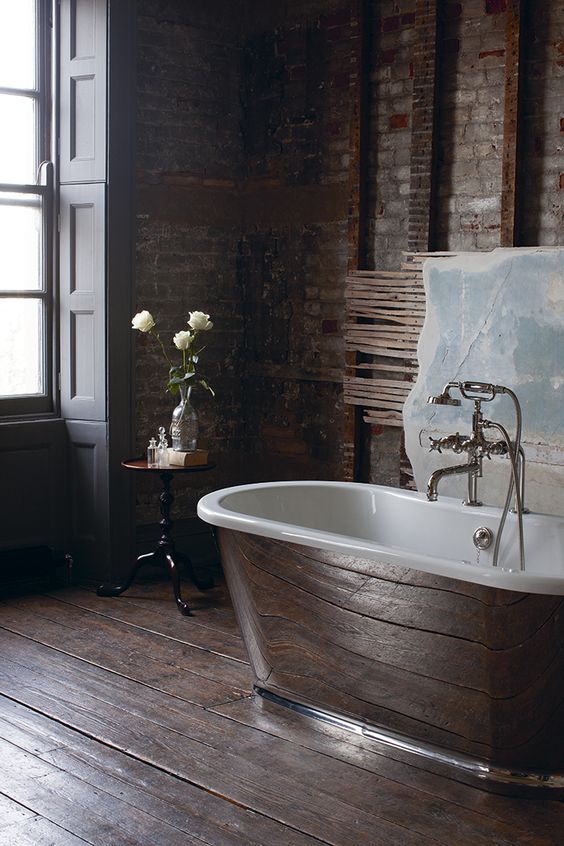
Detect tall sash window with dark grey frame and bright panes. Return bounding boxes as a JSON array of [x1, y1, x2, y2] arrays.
[[0, 0, 54, 416]]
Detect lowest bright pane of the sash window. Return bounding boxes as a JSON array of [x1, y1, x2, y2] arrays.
[[0, 297, 43, 397]]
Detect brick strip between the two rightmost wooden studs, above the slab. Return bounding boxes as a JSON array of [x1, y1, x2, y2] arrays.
[[435, 0, 505, 250]]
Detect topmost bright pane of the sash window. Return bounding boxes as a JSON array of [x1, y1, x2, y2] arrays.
[[0, 0, 35, 88]]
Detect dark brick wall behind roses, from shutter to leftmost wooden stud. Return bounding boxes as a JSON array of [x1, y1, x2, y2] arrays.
[[136, 0, 351, 522]]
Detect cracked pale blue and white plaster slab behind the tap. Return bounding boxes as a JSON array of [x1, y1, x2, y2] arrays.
[[404, 247, 564, 514]]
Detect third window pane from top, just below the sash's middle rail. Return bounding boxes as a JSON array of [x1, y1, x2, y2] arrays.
[[0, 194, 42, 291]]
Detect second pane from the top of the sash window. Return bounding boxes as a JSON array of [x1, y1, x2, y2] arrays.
[[0, 94, 37, 184]]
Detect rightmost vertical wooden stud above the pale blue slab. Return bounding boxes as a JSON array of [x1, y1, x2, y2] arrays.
[[500, 0, 523, 247]]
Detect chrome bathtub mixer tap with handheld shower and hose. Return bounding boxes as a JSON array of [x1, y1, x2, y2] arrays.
[[427, 382, 527, 570]]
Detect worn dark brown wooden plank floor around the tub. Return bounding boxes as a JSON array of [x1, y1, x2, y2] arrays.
[[0, 581, 564, 846]]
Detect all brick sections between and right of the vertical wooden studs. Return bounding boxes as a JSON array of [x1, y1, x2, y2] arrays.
[[363, 0, 564, 484]]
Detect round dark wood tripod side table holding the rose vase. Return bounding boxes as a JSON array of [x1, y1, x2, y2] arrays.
[[97, 458, 215, 615]]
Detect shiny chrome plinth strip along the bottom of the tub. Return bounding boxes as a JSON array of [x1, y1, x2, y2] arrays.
[[253, 684, 564, 799]]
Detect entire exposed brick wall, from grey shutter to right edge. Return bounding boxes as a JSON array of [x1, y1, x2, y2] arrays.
[[136, 0, 564, 521]]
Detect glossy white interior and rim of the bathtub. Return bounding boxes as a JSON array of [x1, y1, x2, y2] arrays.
[[198, 482, 564, 594]]
